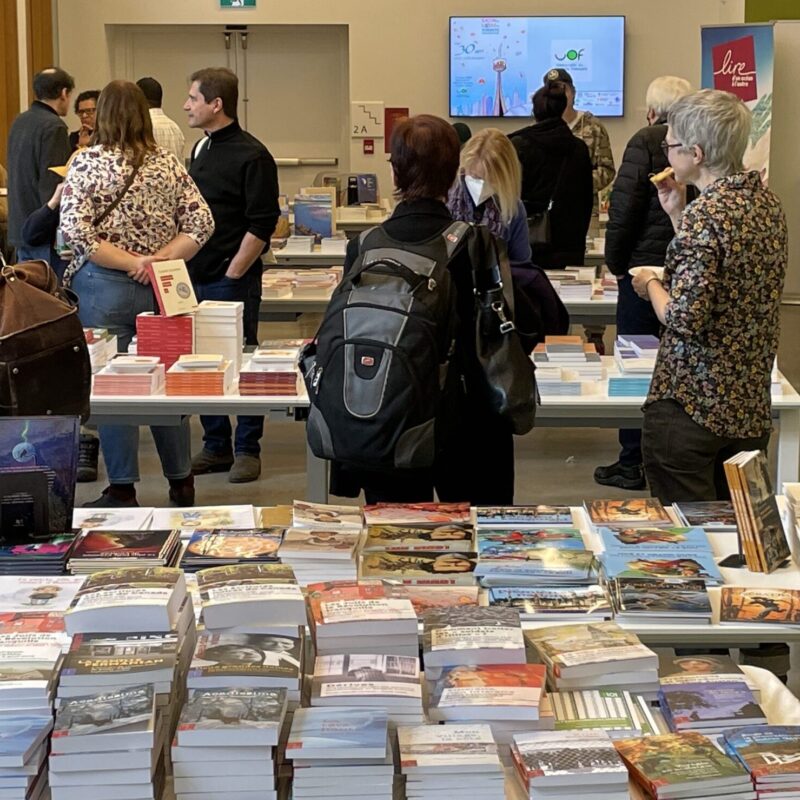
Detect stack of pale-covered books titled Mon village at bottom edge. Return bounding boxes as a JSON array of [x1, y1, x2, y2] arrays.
[[397, 725, 505, 800]]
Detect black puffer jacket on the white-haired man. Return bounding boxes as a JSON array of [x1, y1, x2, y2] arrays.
[[606, 120, 675, 275]]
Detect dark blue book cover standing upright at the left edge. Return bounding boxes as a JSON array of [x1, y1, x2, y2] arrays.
[[0, 416, 80, 536]]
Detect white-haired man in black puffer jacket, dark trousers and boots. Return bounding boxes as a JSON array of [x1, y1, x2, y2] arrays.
[[594, 75, 692, 490]]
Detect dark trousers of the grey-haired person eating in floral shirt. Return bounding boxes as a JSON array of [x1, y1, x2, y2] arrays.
[[642, 400, 769, 503]]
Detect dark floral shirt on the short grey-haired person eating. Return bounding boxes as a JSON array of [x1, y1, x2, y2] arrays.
[[645, 172, 788, 439]]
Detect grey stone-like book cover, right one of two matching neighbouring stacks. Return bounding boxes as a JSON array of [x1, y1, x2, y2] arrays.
[[178, 688, 286, 740]]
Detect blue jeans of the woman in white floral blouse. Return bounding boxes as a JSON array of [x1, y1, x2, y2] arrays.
[[72, 261, 192, 484]]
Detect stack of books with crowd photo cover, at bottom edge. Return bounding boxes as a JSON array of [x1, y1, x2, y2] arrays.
[[511, 730, 630, 800]]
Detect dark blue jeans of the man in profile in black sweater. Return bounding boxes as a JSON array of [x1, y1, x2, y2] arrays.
[[194, 266, 264, 456]]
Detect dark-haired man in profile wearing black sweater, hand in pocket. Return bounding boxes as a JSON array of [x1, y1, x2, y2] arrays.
[[183, 68, 280, 483]]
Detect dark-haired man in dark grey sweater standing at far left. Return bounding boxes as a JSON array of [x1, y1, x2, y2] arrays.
[[8, 67, 75, 267]]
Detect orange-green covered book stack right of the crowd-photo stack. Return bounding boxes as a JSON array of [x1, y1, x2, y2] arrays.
[[614, 733, 752, 800]]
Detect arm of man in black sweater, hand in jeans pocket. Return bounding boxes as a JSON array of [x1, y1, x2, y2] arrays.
[[225, 154, 281, 280]]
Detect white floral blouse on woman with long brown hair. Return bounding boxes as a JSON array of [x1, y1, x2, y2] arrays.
[[61, 145, 214, 283]]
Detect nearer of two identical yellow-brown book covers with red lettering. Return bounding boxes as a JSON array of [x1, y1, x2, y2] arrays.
[[361, 551, 478, 584]]
